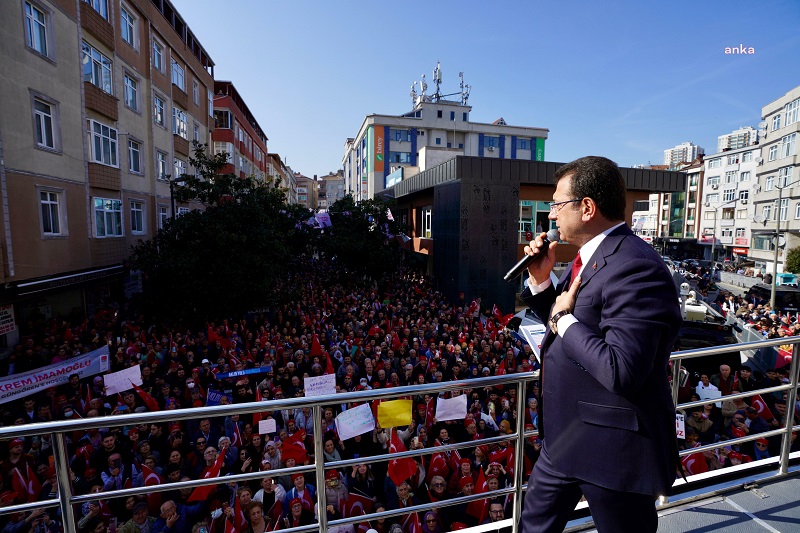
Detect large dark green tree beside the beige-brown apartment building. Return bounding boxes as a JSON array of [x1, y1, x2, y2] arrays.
[[130, 142, 313, 321]]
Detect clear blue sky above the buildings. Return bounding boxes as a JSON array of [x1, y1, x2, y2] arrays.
[[172, 0, 800, 176]]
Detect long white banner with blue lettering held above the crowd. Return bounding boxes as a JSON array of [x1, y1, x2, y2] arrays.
[[0, 346, 109, 403]]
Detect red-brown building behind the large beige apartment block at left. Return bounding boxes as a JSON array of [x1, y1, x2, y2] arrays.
[[212, 81, 268, 182]]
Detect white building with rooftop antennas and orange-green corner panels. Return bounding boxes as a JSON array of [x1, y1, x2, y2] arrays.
[[342, 97, 548, 199]]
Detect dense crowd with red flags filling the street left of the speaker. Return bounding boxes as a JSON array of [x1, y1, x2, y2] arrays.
[[0, 262, 541, 533]]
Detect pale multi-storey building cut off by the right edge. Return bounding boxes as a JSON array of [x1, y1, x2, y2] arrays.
[[750, 86, 800, 272]]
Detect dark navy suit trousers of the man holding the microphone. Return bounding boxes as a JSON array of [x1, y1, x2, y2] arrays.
[[521, 440, 658, 533]]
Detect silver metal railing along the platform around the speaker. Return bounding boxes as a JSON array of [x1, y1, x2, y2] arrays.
[[0, 336, 800, 533]]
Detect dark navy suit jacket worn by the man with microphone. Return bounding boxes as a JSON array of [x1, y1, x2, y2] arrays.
[[522, 226, 681, 495]]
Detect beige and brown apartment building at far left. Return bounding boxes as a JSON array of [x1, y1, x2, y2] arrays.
[[0, 0, 214, 345]]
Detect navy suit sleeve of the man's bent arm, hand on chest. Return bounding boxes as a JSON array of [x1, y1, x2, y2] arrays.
[[563, 258, 680, 395]]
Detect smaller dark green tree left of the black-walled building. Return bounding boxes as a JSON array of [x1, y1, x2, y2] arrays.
[[317, 194, 404, 278]]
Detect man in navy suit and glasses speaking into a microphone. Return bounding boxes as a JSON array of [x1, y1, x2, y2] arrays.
[[522, 157, 681, 533]]
